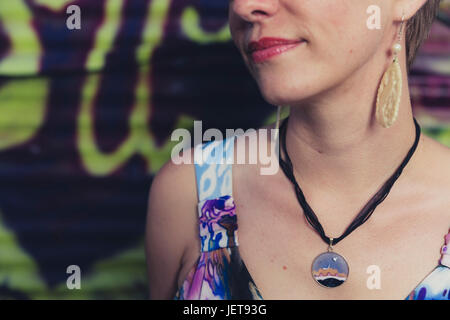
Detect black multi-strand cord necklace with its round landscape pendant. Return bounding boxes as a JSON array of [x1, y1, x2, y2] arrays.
[[280, 117, 421, 288]]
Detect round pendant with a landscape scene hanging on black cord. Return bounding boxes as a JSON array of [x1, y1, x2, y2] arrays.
[[311, 251, 349, 288]]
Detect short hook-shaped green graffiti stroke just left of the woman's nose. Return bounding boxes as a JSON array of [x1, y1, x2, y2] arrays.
[[181, 7, 231, 44]]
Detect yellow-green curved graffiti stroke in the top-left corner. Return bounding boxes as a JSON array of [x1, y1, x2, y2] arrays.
[[0, 0, 42, 75]]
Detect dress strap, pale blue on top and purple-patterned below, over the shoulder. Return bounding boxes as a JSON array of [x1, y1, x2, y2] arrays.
[[194, 136, 238, 252]]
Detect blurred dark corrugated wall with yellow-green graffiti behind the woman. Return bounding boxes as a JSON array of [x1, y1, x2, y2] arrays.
[[0, 0, 450, 299]]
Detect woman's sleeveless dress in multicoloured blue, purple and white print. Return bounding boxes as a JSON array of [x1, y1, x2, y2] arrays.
[[175, 136, 450, 300]]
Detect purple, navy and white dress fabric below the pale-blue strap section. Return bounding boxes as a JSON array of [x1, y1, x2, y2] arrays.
[[175, 195, 260, 300]]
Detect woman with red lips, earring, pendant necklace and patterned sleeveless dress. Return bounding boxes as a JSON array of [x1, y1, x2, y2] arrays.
[[147, 0, 450, 299]]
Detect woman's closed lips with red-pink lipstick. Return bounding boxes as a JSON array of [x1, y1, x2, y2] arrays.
[[247, 37, 305, 63]]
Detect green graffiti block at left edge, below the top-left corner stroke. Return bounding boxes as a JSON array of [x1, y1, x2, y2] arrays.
[[0, 78, 49, 150]]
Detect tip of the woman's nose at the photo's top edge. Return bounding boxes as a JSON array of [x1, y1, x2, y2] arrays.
[[231, 0, 279, 23]]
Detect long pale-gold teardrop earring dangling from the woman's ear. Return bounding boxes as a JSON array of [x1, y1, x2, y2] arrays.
[[376, 15, 405, 128]]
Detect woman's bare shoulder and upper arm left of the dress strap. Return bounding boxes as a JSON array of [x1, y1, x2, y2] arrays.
[[146, 150, 198, 299]]
